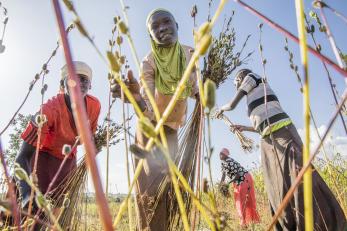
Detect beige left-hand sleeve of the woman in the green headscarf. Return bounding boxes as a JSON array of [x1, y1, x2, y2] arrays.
[[140, 55, 155, 120]]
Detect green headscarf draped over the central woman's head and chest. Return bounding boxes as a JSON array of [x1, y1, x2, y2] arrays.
[[146, 9, 192, 99]]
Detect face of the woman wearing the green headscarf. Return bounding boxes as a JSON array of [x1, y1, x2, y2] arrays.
[[148, 11, 178, 46]]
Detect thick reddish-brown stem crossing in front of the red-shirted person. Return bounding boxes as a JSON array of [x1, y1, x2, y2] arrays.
[[52, 0, 113, 231]]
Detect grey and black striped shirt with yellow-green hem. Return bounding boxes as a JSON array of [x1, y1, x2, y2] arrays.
[[239, 73, 291, 136]]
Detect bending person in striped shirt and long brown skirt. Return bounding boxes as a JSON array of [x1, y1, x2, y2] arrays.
[[219, 69, 346, 230]]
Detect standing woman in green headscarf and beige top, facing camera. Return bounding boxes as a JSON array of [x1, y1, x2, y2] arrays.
[[111, 9, 198, 230]]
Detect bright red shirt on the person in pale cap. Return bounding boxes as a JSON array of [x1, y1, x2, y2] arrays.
[[21, 94, 100, 159]]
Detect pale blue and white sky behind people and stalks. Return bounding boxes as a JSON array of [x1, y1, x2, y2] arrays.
[[0, 0, 347, 193]]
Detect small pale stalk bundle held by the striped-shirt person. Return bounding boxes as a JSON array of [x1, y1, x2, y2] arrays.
[[211, 108, 254, 153]]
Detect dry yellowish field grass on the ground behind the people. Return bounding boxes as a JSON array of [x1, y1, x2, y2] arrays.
[[73, 154, 347, 231]]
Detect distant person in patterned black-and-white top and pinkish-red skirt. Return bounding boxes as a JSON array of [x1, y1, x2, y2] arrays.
[[219, 148, 259, 227]]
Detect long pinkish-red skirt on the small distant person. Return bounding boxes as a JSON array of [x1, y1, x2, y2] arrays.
[[233, 173, 260, 226]]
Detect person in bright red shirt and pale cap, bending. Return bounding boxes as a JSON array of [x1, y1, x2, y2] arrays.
[[16, 61, 100, 207]]
